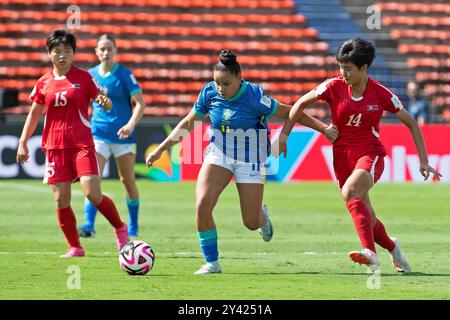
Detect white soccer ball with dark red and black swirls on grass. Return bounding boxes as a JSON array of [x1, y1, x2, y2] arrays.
[[119, 240, 155, 276]]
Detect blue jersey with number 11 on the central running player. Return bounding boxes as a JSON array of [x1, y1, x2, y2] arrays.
[[194, 80, 278, 163]]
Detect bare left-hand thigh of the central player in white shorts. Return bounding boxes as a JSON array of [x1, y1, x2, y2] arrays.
[[195, 163, 233, 205]]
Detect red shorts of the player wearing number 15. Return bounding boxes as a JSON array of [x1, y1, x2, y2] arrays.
[[44, 147, 99, 184]]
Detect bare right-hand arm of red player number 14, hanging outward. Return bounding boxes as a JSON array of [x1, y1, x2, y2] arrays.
[[395, 109, 442, 180]]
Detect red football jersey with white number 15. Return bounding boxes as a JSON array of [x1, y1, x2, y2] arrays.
[[30, 66, 99, 150]]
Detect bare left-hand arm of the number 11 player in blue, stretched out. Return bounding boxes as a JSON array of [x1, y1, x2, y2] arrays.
[[145, 110, 201, 167]]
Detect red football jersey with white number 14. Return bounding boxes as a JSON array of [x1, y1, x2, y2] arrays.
[[314, 77, 403, 150]]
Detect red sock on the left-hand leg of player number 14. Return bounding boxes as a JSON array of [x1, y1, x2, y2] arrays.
[[346, 198, 376, 252]]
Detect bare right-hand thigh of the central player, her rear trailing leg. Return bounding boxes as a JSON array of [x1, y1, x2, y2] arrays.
[[236, 183, 264, 226]]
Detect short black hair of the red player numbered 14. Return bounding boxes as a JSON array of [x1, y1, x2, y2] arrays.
[[336, 38, 375, 68]]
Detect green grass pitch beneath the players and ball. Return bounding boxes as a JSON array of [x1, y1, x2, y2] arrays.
[[0, 180, 450, 300]]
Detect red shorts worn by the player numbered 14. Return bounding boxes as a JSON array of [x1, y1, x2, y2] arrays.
[[333, 147, 386, 189]]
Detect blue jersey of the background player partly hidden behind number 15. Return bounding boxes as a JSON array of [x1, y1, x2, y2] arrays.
[[89, 63, 141, 144]]
